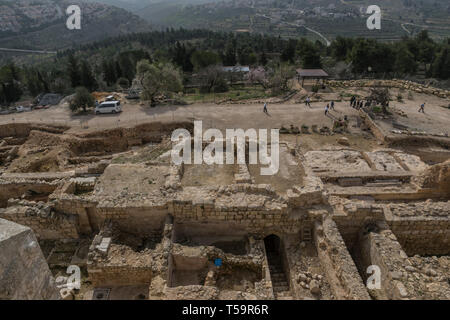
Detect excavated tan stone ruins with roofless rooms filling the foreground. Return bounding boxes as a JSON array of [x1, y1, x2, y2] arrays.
[[0, 122, 450, 300]]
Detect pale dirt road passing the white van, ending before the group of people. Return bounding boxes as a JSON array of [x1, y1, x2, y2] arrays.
[[0, 102, 357, 132]]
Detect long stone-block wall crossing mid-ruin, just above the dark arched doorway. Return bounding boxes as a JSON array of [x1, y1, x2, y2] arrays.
[[88, 178, 324, 234]]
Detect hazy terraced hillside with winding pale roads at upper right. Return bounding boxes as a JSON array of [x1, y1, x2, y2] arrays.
[[141, 0, 450, 41]]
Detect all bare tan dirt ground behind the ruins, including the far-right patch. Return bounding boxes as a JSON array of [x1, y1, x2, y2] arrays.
[[0, 88, 450, 139]]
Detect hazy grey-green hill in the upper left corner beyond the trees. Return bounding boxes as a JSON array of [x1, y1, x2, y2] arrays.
[[0, 0, 150, 50]]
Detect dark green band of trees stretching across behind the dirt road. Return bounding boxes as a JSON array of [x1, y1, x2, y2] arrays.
[[0, 29, 450, 105]]
